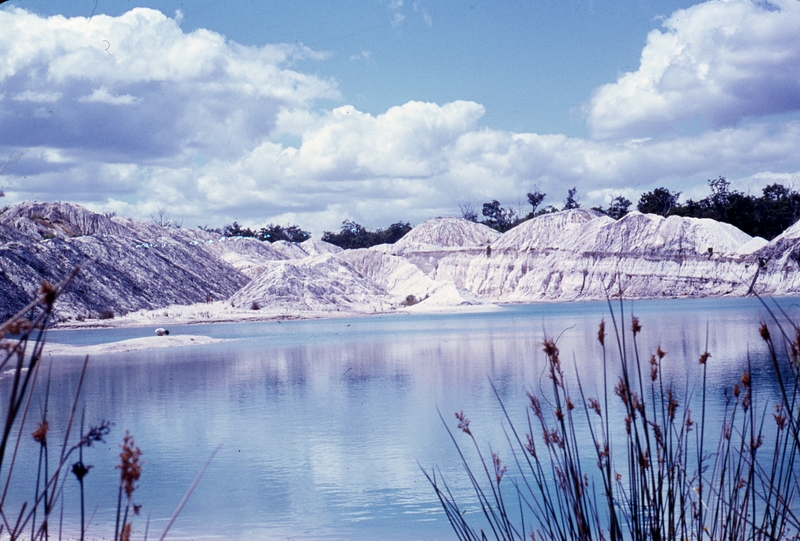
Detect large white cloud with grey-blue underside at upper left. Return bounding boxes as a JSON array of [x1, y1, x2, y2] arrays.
[[0, 8, 338, 163]]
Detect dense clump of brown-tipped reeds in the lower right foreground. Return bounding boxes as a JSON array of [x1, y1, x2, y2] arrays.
[[425, 301, 800, 541]]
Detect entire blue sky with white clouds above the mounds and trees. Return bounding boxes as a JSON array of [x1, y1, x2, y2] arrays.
[[0, 0, 800, 236]]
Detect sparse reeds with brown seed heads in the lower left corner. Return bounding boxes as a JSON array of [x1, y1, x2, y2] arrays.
[[0, 276, 216, 541]]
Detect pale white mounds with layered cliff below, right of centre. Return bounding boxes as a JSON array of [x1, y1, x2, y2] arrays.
[[424, 209, 759, 302]]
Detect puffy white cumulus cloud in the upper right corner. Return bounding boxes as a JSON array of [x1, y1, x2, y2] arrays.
[[588, 0, 800, 141]]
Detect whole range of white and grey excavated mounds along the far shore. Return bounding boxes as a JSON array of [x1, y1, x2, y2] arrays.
[[0, 203, 800, 318]]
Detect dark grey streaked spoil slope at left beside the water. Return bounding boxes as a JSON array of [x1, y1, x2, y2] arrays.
[[0, 203, 249, 318]]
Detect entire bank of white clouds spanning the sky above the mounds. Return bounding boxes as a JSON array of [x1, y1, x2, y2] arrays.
[[0, 0, 800, 233]]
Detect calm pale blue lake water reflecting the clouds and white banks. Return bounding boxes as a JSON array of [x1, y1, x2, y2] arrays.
[[0, 299, 800, 540]]
